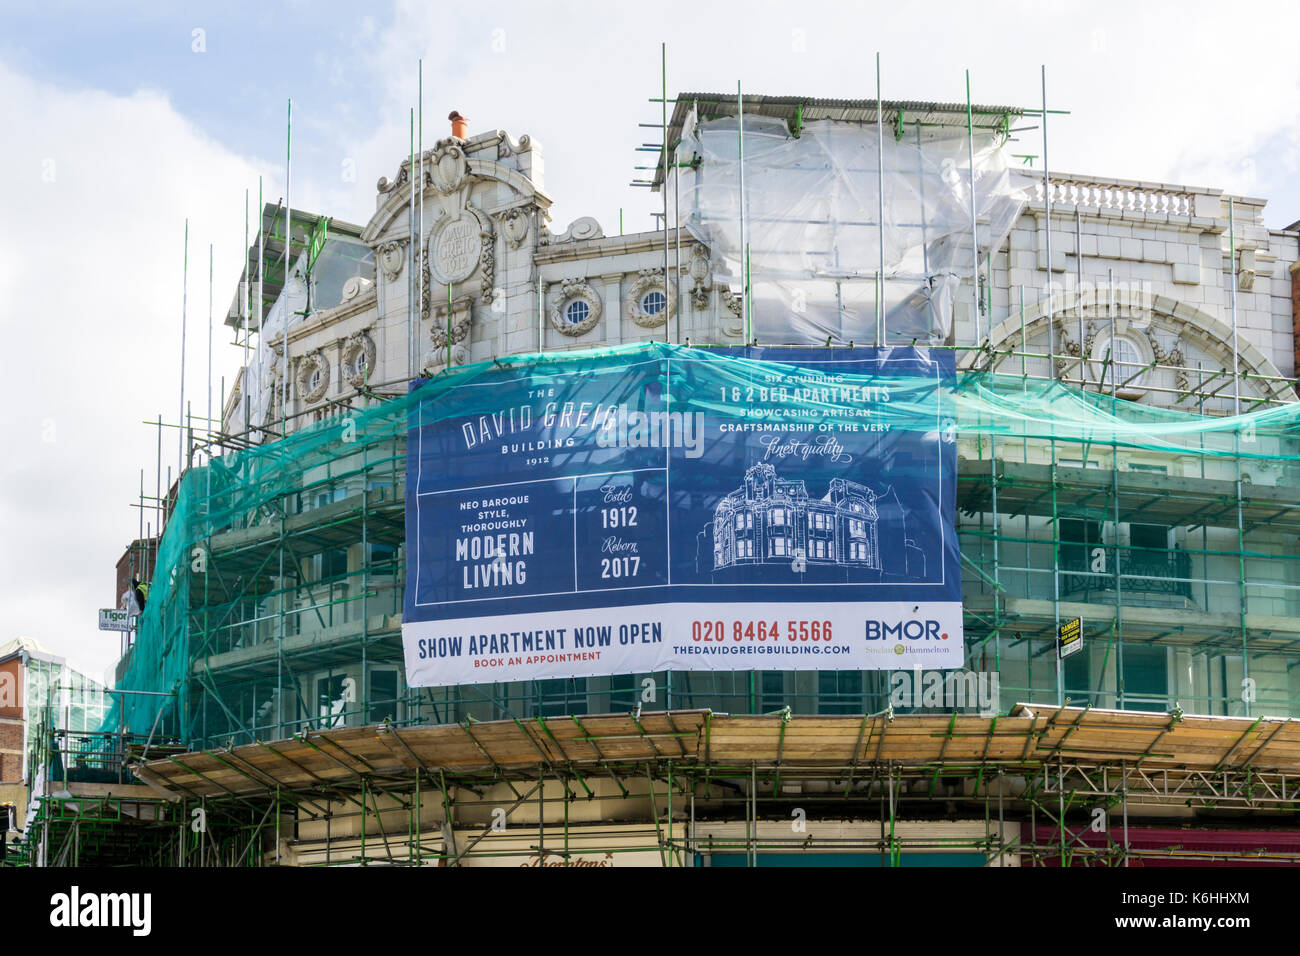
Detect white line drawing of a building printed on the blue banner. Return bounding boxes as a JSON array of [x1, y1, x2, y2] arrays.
[[714, 462, 888, 572]]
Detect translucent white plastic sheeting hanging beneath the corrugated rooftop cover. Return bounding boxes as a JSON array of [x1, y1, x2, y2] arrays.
[[677, 116, 1028, 345]]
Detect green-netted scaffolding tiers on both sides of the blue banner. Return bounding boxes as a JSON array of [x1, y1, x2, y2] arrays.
[[96, 317, 1300, 745]]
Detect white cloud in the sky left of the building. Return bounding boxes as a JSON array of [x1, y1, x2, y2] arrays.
[[0, 64, 266, 675]]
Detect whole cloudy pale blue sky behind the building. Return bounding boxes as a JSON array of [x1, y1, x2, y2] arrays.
[[0, 0, 1300, 675]]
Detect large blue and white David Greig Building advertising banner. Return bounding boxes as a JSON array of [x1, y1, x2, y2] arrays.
[[402, 345, 963, 687]]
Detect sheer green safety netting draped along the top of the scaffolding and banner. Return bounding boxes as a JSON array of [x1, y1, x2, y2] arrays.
[[103, 342, 1300, 739]]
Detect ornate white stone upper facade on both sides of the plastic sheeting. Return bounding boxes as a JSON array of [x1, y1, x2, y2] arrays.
[[218, 113, 1300, 433]]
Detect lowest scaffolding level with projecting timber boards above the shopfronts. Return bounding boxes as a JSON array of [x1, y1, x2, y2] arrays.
[[20, 705, 1300, 866]]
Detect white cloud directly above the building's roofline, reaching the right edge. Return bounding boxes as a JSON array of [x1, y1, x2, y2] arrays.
[[340, 0, 1300, 232]]
